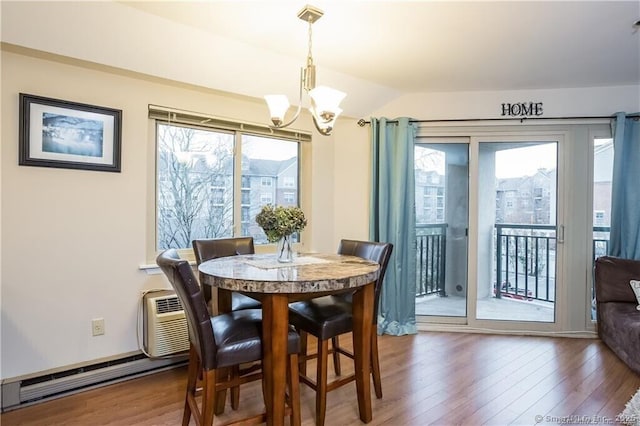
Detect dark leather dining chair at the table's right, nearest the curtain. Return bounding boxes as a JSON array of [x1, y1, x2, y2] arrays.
[[289, 239, 393, 426]]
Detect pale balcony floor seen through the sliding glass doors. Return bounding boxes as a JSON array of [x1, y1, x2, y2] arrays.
[[416, 295, 554, 322]]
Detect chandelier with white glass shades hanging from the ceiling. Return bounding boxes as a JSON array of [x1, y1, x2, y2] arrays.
[[264, 5, 346, 136]]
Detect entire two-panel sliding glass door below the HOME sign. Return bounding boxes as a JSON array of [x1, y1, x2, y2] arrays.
[[414, 131, 563, 329]]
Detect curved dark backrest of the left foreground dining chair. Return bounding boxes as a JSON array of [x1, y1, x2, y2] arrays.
[[156, 249, 217, 370]]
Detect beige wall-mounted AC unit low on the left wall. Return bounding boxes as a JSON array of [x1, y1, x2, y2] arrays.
[[143, 290, 189, 357]]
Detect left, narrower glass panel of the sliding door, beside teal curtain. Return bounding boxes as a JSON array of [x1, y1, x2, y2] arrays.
[[415, 138, 469, 318]]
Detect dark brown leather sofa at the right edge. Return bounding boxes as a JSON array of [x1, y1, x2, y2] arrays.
[[595, 256, 640, 374]]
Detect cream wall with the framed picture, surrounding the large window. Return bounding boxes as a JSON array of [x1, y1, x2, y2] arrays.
[[0, 45, 350, 378]]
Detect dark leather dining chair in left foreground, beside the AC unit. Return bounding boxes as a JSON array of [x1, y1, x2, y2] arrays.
[[156, 249, 300, 426]]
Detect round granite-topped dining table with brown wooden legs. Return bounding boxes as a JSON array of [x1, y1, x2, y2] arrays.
[[198, 253, 380, 425]]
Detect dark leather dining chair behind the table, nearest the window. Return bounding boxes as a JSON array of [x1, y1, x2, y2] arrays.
[[191, 237, 260, 312]]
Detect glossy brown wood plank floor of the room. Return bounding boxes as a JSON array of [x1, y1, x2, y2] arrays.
[[0, 332, 640, 426]]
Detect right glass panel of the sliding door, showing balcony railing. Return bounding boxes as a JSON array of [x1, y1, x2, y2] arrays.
[[476, 140, 561, 323]]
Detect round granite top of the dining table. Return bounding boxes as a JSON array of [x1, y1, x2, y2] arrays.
[[198, 254, 380, 293]]
